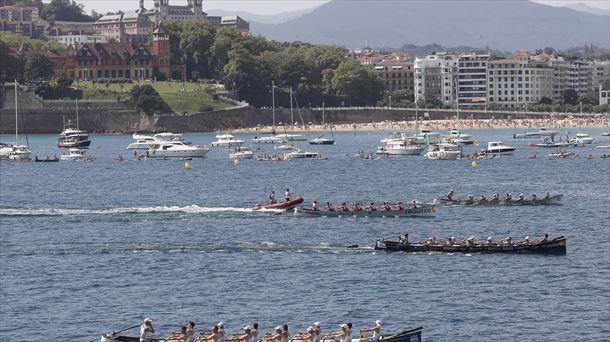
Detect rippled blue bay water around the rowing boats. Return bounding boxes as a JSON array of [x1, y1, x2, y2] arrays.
[[0, 129, 610, 341]]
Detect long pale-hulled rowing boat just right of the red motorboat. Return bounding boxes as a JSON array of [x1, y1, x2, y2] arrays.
[[294, 203, 436, 217]]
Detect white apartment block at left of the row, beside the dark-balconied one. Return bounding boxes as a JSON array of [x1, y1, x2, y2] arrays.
[[415, 52, 458, 105]]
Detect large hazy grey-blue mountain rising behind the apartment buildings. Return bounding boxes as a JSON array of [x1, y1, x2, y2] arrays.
[[250, 0, 610, 51]]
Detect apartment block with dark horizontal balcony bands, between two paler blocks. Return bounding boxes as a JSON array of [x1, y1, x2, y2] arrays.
[[457, 53, 490, 109]]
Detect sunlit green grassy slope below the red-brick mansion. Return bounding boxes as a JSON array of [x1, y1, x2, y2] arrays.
[[79, 82, 231, 114]]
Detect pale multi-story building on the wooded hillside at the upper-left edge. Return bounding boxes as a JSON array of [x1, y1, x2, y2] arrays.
[[0, 6, 48, 38]]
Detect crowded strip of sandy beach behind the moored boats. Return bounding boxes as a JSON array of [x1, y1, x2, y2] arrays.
[[226, 118, 610, 133]]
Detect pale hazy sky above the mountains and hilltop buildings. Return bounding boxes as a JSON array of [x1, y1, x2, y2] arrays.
[[71, 0, 610, 14]]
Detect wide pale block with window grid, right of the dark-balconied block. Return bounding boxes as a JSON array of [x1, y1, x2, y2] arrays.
[[487, 51, 554, 108]]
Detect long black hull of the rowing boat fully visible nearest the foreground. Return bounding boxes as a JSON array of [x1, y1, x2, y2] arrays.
[[375, 236, 567, 255]]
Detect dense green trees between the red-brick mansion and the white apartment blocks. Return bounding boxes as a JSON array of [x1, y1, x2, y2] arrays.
[[166, 21, 384, 106]]
